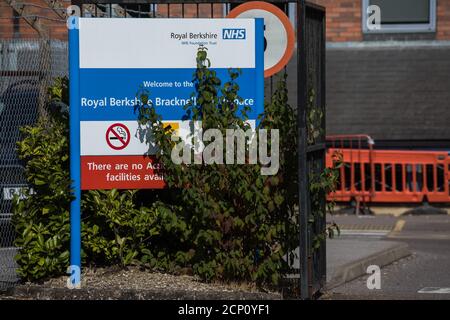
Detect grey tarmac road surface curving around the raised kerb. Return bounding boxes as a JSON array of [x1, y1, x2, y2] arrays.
[[324, 215, 450, 299]]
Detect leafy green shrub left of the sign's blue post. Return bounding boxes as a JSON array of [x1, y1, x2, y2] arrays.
[[13, 114, 72, 280]]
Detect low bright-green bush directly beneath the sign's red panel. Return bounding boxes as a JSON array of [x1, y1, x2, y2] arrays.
[[82, 190, 188, 271]]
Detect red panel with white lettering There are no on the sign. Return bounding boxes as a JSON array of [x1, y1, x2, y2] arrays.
[[81, 156, 165, 190]]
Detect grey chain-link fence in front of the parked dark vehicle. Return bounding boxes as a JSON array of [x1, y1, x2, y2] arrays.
[[0, 39, 68, 290]]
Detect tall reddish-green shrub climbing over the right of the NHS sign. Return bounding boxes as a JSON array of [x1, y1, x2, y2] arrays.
[[135, 48, 298, 283]]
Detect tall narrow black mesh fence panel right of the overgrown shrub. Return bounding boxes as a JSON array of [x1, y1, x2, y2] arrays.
[[299, 5, 326, 298]]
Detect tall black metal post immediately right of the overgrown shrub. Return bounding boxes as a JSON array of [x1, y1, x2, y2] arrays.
[[297, 0, 309, 299]]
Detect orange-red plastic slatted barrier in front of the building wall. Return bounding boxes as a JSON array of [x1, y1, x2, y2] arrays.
[[326, 135, 450, 205]]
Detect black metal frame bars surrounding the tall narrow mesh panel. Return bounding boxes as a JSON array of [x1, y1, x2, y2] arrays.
[[297, 1, 326, 299]]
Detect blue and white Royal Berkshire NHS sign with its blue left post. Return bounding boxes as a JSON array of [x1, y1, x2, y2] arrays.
[[69, 18, 264, 286]]
